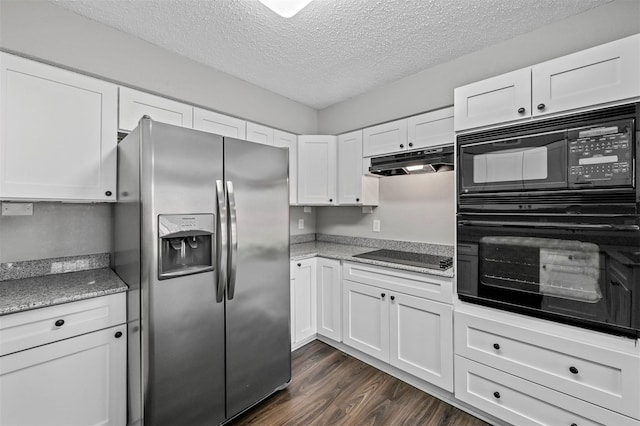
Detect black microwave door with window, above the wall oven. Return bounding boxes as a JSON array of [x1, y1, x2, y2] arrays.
[[459, 132, 567, 195]]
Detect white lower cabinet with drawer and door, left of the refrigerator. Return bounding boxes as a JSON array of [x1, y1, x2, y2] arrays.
[[0, 293, 127, 426]]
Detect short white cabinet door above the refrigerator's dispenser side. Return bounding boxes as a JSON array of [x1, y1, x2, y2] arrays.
[[118, 87, 193, 132]]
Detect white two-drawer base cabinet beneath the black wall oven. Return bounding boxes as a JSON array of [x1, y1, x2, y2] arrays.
[[455, 305, 640, 425]]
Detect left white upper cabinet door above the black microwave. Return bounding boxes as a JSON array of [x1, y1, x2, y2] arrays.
[[453, 68, 531, 131]]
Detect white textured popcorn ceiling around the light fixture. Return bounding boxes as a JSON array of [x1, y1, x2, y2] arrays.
[[49, 0, 611, 109]]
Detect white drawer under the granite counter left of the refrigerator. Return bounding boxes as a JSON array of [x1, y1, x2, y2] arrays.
[[0, 293, 126, 355]]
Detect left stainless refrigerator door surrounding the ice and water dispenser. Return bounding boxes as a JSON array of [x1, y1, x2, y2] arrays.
[[140, 120, 225, 426]]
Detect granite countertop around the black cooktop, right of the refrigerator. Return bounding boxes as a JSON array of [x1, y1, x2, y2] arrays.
[[289, 241, 454, 278]]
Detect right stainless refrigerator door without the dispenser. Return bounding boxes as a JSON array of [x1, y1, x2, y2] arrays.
[[224, 138, 291, 418]]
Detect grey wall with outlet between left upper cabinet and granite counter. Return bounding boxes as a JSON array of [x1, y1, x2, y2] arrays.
[[0, 202, 113, 263]]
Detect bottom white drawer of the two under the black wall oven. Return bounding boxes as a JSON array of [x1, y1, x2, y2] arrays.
[[455, 356, 640, 426]]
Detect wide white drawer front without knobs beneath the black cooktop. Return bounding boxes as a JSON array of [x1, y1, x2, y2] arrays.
[[342, 262, 453, 303]]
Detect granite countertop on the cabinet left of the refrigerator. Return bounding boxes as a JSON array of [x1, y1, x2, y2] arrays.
[[0, 268, 128, 315]]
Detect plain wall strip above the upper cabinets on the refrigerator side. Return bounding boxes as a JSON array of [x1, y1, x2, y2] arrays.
[[0, 0, 317, 133]]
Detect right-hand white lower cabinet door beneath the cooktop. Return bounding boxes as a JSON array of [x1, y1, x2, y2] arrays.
[[389, 293, 453, 392]]
